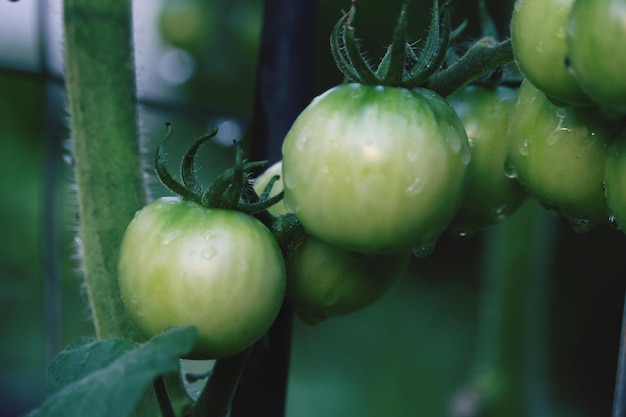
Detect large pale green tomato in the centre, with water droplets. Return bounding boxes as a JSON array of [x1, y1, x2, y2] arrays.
[[282, 83, 470, 253]]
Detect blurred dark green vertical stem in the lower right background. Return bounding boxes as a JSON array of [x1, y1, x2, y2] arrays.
[[458, 204, 555, 417]]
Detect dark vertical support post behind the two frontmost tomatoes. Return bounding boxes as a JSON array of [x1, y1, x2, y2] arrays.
[[231, 0, 318, 417]]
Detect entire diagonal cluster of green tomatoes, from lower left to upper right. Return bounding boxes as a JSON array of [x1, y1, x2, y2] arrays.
[[114, 0, 626, 357]]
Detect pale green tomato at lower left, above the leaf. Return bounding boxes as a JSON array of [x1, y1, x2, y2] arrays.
[[118, 197, 286, 358]]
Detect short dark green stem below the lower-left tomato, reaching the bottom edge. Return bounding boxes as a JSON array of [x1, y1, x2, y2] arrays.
[[189, 348, 252, 417]]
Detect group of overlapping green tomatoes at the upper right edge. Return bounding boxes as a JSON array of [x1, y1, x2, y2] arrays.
[[508, 0, 626, 231]]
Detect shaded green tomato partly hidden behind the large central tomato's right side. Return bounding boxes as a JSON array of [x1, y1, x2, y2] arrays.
[[446, 86, 527, 235]]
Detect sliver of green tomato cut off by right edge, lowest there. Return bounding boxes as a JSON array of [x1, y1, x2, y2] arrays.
[[604, 131, 626, 229]]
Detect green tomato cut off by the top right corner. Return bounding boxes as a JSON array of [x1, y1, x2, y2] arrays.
[[567, 0, 626, 114]]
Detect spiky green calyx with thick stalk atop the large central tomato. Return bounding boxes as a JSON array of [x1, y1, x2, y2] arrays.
[[330, 0, 513, 97]]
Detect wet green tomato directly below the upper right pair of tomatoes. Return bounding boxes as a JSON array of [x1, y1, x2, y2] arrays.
[[508, 81, 614, 225]]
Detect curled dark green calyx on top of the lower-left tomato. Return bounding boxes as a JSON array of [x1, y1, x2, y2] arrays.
[[154, 123, 283, 214]]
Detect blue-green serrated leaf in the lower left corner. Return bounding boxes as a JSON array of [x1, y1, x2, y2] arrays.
[[28, 327, 197, 417]]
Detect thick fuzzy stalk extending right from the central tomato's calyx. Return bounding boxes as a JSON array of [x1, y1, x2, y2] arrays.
[[426, 38, 513, 97]]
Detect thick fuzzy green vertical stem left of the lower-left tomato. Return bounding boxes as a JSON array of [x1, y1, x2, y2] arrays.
[[64, 0, 146, 338]]
